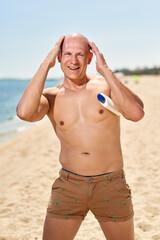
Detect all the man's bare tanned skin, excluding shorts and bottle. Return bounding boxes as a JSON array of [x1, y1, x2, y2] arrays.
[[17, 34, 144, 240]]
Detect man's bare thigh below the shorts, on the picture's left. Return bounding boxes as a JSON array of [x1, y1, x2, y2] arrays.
[[43, 216, 82, 240]]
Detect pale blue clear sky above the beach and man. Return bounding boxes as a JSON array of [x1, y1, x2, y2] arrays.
[[0, 0, 160, 79]]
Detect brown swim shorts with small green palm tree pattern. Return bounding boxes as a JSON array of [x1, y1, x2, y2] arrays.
[[47, 169, 134, 222]]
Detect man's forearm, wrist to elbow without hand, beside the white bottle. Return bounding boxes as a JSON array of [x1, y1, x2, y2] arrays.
[[102, 66, 144, 121]]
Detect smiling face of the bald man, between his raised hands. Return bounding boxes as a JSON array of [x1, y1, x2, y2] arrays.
[[61, 37, 91, 80]]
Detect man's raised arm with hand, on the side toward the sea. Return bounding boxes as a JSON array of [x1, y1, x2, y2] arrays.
[[17, 36, 64, 122]]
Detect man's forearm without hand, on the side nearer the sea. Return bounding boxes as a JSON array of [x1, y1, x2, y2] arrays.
[[17, 60, 49, 118]]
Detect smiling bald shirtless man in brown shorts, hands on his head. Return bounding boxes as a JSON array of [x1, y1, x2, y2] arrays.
[[17, 34, 144, 240]]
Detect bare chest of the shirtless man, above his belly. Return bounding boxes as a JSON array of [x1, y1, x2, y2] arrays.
[[54, 86, 110, 130]]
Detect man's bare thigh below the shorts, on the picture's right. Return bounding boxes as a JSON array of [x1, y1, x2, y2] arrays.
[[99, 218, 134, 240]]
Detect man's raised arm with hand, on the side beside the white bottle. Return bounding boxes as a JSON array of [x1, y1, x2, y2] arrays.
[[89, 42, 144, 122]]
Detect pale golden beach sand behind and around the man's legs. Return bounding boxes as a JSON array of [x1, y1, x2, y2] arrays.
[[0, 76, 160, 240]]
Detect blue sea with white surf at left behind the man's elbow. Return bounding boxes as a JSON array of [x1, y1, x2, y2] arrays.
[[0, 79, 62, 144]]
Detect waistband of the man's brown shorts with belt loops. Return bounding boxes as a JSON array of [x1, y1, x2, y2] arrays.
[[59, 168, 125, 182]]
